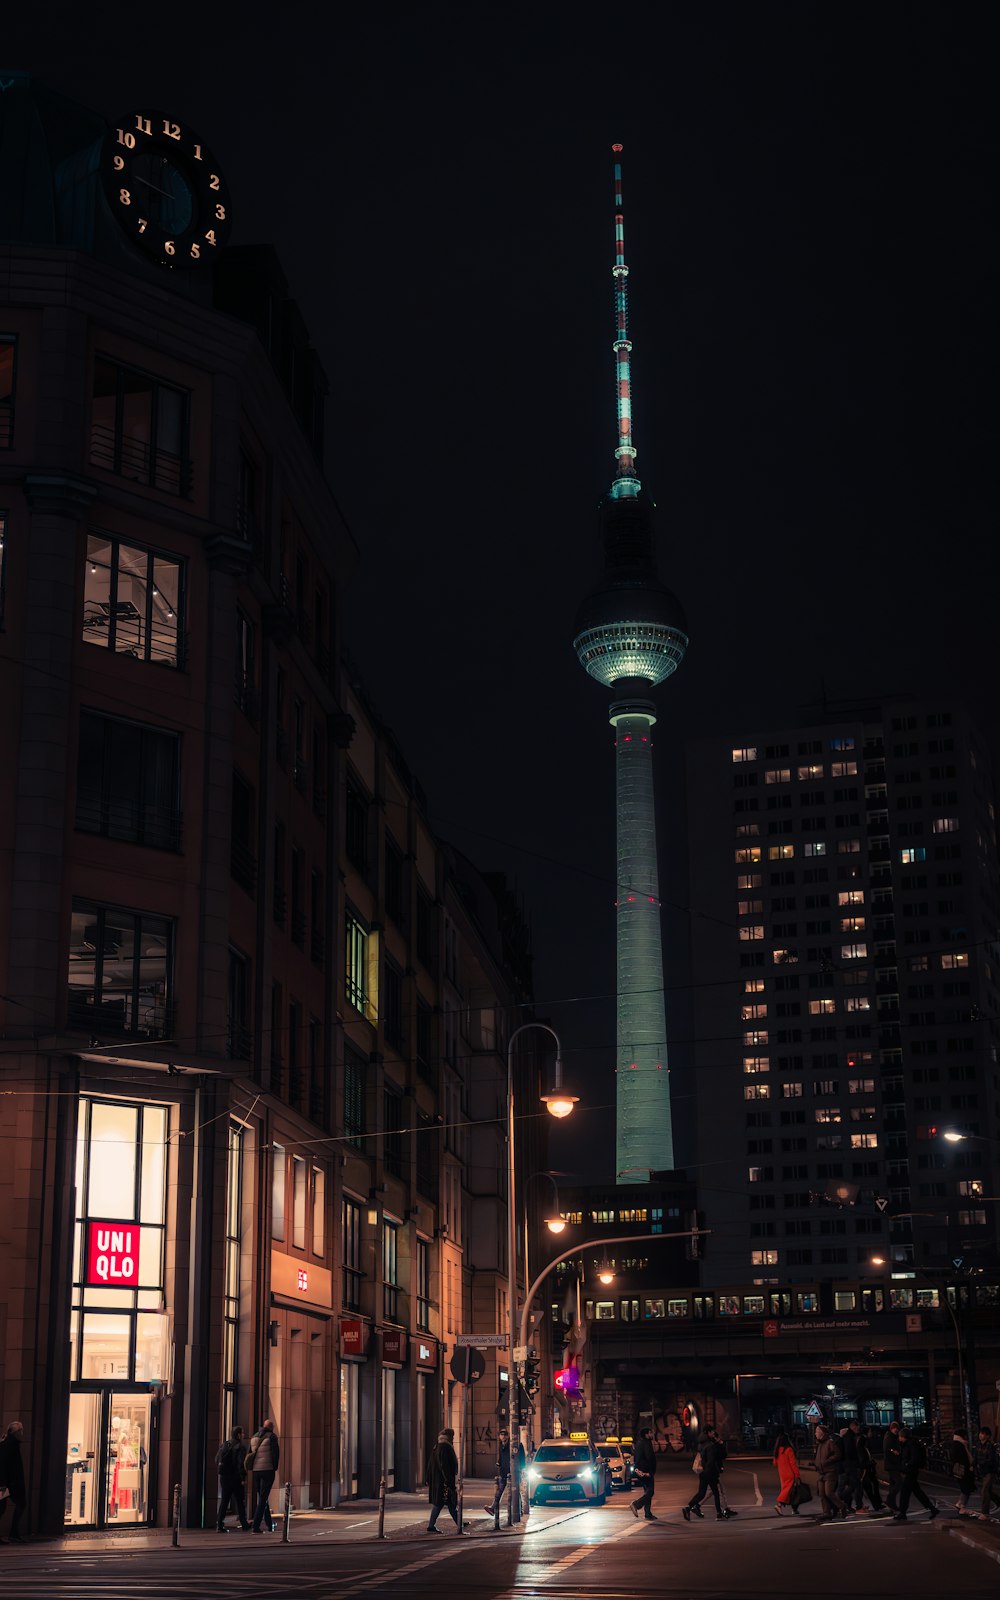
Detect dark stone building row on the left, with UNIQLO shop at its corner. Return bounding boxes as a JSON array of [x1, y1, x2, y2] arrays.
[[0, 74, 537, 1533]]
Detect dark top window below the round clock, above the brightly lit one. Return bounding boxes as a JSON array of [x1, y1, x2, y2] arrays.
[[90, 355, 192, 494]]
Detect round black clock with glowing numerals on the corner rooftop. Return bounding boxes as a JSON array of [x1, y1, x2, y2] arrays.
[[101, 110, 230, 267]]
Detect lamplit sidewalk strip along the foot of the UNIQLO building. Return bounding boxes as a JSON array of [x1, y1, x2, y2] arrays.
[[5, 1478, 566, 1557]]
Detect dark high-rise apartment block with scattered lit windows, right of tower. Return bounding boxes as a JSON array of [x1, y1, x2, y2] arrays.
[[688, 699, 1000, 1292]]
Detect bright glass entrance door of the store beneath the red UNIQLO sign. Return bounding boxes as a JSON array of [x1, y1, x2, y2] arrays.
[[66, 1386, 157, 1528]]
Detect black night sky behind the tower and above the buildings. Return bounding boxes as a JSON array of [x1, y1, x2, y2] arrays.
[[9, 3, 1000, 1178]]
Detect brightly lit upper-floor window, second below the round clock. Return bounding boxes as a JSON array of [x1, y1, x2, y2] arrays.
[[83, 533, 184, 667]]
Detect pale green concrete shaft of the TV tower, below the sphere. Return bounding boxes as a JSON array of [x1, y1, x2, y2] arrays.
[[611, 701, 674, 1182]]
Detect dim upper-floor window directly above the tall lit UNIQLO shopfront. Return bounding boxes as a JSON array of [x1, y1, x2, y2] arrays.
[[69, 899, 173, 1038]]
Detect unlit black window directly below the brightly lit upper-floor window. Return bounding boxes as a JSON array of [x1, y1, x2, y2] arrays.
[[75, 710, 181, 850]]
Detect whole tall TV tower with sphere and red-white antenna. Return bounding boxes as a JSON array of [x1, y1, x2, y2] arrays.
[[573, 144, 688, 1184]]
